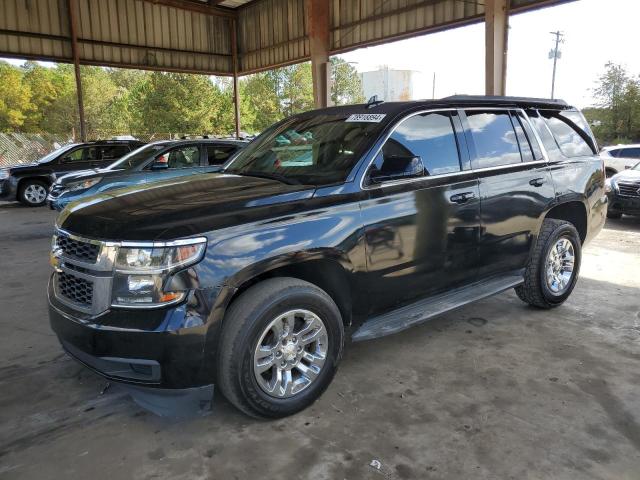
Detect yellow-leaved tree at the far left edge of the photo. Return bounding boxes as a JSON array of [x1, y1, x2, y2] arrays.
[[0, 62, 33, 132]]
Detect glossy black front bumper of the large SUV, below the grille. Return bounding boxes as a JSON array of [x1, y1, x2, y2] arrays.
[[49, 277, 214, 389]]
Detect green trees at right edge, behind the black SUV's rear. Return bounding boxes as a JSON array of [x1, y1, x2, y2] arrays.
[[584, 62, 640, 145]]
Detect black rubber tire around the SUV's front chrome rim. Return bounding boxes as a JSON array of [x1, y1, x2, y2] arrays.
[[217, 277, 344, 418]]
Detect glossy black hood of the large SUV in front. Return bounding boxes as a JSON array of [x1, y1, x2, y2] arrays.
[[57, 173, 315, 241]]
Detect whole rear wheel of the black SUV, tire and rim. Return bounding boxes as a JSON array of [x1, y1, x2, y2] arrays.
[[516, 219, 582, 308]]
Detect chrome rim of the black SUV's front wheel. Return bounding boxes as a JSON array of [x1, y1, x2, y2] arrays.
[[253, 309, 328, 398]]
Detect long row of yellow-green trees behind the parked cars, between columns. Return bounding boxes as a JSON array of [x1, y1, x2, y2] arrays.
[[0, 58, 363, 138]]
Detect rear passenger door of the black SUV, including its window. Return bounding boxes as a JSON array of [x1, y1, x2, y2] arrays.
[[461, 109, 555, 278]]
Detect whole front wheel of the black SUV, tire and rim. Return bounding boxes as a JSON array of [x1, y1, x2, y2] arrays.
[[218, 278, 344, 418]]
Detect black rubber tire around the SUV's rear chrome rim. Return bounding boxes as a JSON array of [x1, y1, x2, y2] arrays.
[[515, 219, 582, 309]]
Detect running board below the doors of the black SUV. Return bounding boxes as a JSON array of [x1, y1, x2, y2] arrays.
[[351, 273, 524, 342]]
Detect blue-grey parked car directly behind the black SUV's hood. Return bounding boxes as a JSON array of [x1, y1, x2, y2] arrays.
[[47, 138, 247, 210]]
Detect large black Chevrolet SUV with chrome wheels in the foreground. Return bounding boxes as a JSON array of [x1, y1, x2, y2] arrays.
[[49, 96, 607, 417]]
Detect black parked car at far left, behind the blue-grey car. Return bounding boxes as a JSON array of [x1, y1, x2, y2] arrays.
[[0, 140, 144, 207]]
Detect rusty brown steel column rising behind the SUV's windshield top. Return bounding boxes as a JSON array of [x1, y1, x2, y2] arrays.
[[306, 0, 331, 108]]
